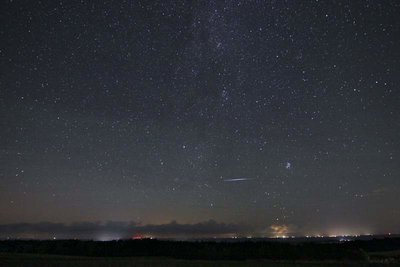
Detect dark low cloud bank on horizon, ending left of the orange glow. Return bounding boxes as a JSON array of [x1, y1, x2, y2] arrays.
[[0, 220, 255, 240]]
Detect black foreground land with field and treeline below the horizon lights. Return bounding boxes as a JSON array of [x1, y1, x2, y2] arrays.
[[0, 239, 400, 267]]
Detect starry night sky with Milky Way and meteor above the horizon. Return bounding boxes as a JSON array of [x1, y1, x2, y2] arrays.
[[0, 0, 400, 239]]
